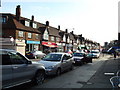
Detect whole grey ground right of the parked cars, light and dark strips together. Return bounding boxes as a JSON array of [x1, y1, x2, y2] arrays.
[[7, 55, 117, 90]]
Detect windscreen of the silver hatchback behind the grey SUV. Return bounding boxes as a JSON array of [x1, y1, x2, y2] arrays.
[[42, 54, 62, 61]]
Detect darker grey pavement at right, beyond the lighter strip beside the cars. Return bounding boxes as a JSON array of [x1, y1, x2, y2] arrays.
[[82, 57, 120, 88]]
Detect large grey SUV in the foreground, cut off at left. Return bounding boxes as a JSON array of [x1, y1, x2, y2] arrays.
[[0, 49, 45, 89]]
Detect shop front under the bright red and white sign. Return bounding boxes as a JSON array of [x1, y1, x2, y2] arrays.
[[42, 41, 58, 53]]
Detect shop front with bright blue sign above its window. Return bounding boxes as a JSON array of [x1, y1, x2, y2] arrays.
[[26, 40, 40, 51]]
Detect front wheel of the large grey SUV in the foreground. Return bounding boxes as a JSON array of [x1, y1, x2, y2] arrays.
[[33, 71, 45, 85]]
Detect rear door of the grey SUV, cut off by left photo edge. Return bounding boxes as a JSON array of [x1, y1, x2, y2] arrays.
[[0, 52, 13, 88]]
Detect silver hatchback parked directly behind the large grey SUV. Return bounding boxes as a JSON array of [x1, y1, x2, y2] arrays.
[[38, 52, 73, 75]]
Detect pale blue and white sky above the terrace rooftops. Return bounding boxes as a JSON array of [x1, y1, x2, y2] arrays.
[[0, 0, 120, 45]]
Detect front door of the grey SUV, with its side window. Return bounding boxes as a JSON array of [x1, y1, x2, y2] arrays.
[[9, 52, 35, 84]]
